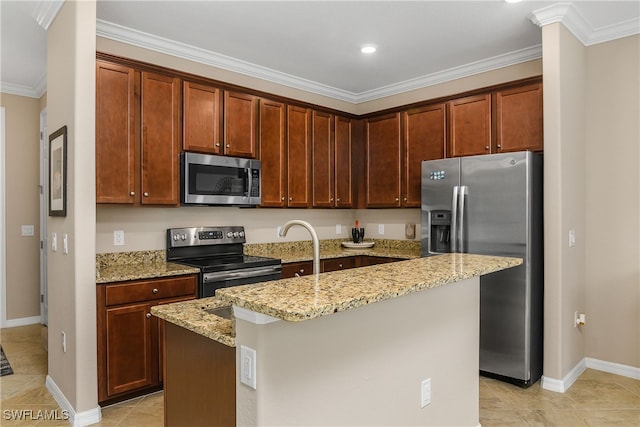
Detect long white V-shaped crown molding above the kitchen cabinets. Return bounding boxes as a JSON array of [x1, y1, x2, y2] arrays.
[[96, 20, 542, 104]]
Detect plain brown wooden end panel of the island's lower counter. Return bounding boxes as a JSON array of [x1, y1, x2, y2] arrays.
[[164, 322, 236, 427]]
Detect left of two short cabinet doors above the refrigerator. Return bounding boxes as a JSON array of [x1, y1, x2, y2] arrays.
[[449, 94, 491, 157]]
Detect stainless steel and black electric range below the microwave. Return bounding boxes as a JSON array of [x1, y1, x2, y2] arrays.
[[167, 226, 282, 298]]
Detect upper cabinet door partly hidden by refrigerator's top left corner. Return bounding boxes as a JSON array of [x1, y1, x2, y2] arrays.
[[402, 104, 446, 208]]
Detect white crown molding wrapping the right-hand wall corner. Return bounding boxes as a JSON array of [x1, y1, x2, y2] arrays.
[[529, 2, 640, 46]]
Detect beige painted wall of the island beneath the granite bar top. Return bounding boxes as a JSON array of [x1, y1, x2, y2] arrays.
[[236, 278, 479, 426]]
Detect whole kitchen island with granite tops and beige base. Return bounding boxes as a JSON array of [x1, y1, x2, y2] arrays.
[[152, 254, 522, 426]]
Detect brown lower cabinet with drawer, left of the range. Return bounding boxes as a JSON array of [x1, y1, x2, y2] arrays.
[[97, 275, 197, 404]]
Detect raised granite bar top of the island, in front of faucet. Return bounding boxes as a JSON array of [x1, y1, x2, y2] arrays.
[[216, 254, 522, 322]]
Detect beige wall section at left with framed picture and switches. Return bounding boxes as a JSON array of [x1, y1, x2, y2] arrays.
[[47, 2, 98, 416]]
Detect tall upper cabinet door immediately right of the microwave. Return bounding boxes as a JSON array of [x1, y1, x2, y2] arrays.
[[259, 99, 287, 208]]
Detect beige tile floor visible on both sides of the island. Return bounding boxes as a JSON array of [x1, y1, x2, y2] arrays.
[[0, 325, 640, 427]]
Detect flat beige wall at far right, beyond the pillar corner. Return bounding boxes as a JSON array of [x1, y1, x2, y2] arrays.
[[584, 36, 640, 367]]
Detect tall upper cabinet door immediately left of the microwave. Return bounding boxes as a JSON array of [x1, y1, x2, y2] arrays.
[[140, 72, 181, 205]]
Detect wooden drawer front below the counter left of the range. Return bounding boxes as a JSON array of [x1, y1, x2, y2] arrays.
[[105, 275, 197, 306]]
